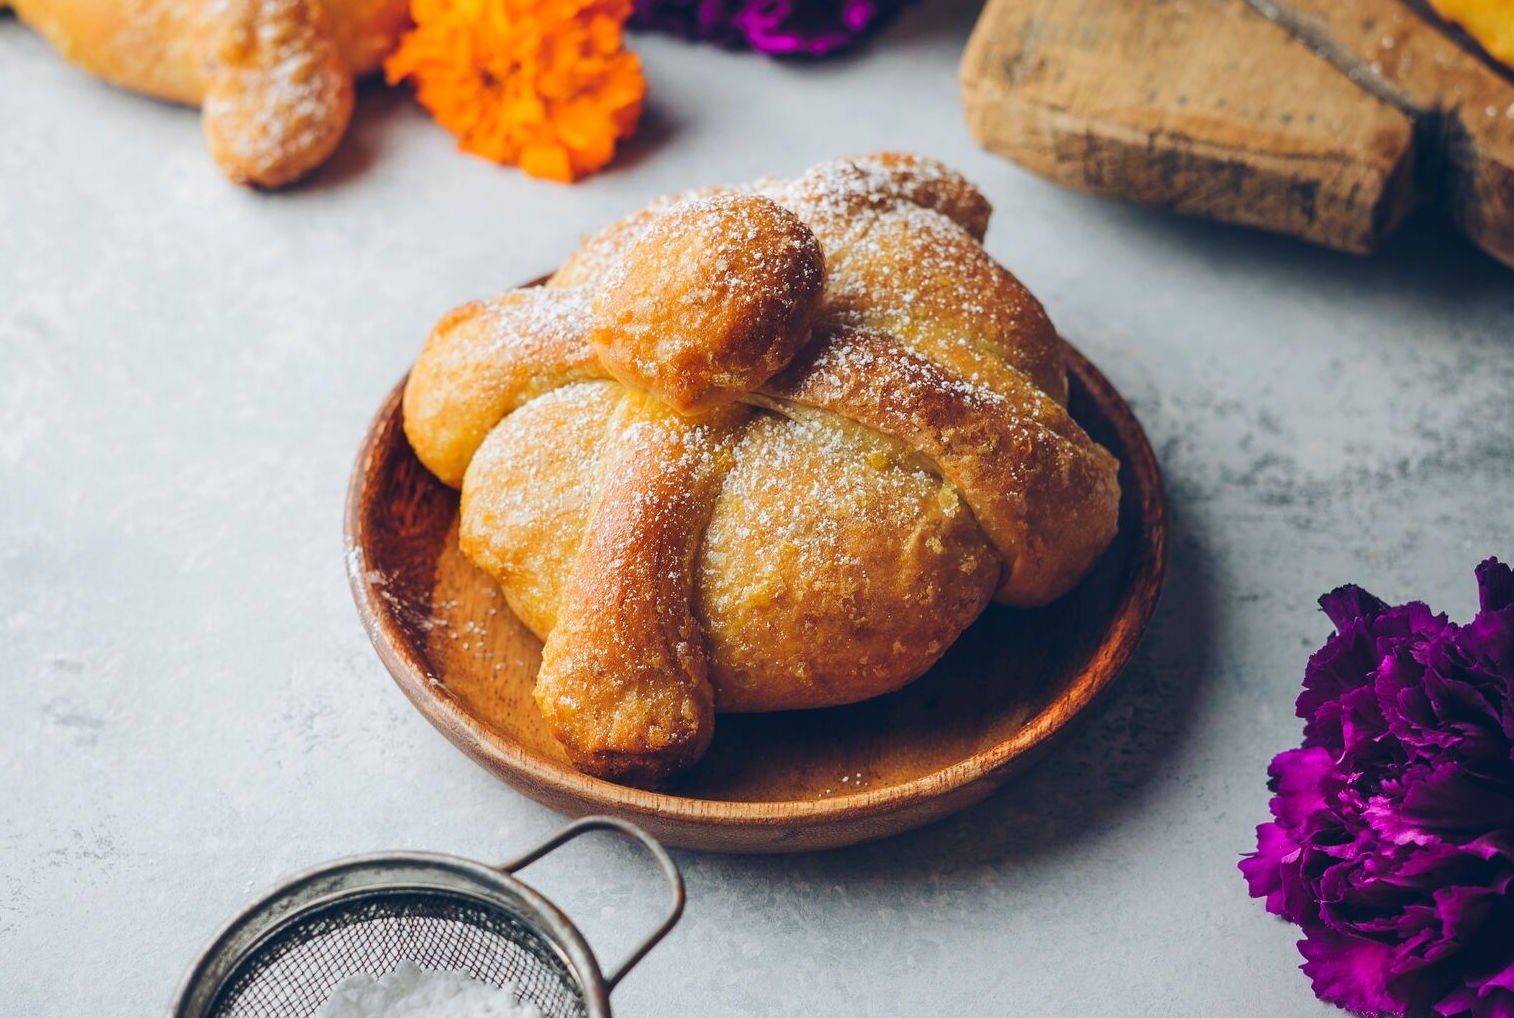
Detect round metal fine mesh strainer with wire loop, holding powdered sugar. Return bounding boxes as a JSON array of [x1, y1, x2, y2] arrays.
[[170, 817, 683, 1018]]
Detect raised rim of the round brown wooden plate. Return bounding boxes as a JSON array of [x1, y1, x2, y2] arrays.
[[344, 333, 1167, 829]]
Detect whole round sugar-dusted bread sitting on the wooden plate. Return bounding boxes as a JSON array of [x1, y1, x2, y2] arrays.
[[404, 155, 1119, 783]]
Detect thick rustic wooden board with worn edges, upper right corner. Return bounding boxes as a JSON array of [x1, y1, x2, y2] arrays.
[[961, 0, 1514, 265]]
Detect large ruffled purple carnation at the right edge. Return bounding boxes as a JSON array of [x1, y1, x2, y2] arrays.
[[1240, 559, 1514, 1018]]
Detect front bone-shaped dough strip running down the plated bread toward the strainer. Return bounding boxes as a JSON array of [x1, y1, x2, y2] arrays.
[[536, 392, 749, 785]]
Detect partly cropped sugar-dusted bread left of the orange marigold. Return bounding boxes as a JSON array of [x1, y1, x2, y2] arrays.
[[0, 0, 409, 188]]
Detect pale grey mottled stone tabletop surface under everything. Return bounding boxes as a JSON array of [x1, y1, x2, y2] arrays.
[[0, 0, 1514, 1018]]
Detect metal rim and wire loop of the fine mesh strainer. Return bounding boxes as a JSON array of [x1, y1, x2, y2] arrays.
[[168, 817, 684, 1018]]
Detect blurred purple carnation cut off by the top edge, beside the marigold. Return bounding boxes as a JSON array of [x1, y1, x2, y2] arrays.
[[631, 0, 910, 56]]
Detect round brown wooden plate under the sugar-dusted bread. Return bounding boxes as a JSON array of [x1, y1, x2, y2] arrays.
[[347, 333, 1166, 851]]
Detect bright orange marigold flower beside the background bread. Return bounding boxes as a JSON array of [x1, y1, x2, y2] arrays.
[[385, 0, 646, 180]]
